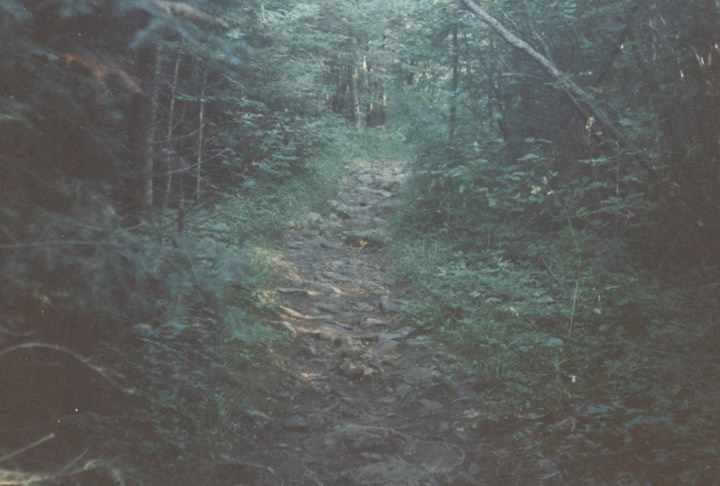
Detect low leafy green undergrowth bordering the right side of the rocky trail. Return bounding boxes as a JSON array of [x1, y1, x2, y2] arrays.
[[392, 139, 720, 485]]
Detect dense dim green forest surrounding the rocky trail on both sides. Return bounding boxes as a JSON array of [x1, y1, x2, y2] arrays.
[[0, 0, 720, 485]]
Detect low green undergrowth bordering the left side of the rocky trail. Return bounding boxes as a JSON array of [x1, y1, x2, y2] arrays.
[[0, 125, 363, 485]]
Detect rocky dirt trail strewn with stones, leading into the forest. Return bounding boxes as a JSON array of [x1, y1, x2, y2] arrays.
[[227, 160, 544, 486]]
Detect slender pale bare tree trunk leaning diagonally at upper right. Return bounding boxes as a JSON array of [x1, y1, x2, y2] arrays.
[[460, 0, 655, 175]]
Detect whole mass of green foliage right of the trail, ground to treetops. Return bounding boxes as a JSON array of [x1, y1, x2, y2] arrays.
[[391, 2, 720, 478]]
